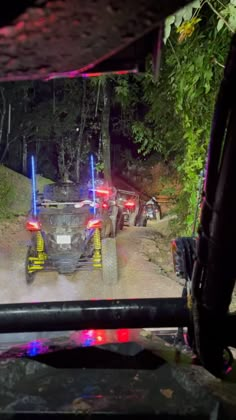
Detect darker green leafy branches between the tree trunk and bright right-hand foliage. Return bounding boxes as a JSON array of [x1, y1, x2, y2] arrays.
[[116, 59, 183, 161]]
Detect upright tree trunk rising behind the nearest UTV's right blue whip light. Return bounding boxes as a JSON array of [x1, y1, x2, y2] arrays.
[[102, 78, 111, 184]]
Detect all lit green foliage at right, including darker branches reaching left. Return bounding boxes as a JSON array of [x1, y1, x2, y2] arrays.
[[117, 0, 231, 234]]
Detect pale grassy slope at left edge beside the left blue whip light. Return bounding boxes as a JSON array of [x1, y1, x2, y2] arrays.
[[0, 165, 52, 218]]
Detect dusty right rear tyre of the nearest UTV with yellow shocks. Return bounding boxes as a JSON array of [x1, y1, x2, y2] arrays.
[[102, 238, 118, 284]]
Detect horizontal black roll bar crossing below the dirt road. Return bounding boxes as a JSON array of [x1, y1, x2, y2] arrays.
[[0, 298, 189, 333]]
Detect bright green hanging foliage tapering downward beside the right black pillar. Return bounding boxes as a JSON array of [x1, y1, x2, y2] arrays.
[[167, 16, 229, 234]]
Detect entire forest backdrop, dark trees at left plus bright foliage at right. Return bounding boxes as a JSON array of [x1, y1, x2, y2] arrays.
[[0, 0, 236, 232]]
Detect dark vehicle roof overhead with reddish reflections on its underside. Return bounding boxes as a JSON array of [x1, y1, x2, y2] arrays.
[[0, 0, 194, 81]]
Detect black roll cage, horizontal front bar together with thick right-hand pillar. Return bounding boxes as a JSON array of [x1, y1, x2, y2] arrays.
[[5, 36, 236, 376]]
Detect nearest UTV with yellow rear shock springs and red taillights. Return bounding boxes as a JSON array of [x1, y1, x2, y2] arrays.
[[26, 159, 118, 283]]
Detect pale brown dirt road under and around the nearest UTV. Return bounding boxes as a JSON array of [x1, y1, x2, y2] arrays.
[[0, 219, 182, 303]]
